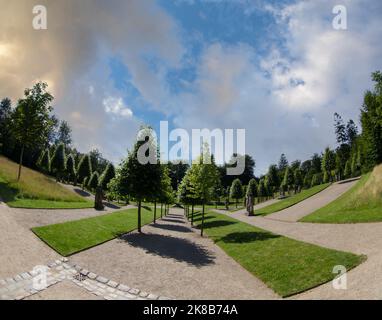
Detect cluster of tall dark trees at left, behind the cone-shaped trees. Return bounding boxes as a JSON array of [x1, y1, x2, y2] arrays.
[[0, 82, 109, 179]]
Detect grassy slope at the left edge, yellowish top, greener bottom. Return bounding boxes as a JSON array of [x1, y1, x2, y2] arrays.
[[0, 156, 93, 208]]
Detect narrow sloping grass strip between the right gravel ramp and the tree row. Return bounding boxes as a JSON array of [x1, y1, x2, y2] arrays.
[[255, 183, 330, 216]]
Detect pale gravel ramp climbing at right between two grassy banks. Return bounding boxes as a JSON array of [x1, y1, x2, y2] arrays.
[[267, 179, 358, 221]]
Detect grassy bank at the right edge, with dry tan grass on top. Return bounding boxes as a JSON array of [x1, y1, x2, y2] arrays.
[[301, 166, 382, 223]]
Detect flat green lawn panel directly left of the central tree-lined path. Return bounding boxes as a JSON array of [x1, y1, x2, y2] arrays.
[[32, 209, 153, 256]]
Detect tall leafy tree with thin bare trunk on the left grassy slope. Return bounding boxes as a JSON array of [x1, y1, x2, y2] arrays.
[[12, 82, 53, 181]]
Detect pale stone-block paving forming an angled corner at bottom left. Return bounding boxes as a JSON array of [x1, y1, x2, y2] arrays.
[[0, 258, 170, 300]]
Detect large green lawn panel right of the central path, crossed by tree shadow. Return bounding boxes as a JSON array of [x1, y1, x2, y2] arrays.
[[196, 212, 365, 297]]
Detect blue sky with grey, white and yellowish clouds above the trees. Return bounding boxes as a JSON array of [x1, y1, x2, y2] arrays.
[[0, 0, 382, 174]]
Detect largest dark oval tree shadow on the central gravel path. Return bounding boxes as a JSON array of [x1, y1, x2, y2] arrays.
[[119, 233, 215, 267]]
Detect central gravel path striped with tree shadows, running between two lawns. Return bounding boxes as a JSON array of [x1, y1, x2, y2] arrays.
[[70, 209, 278, 299]]
